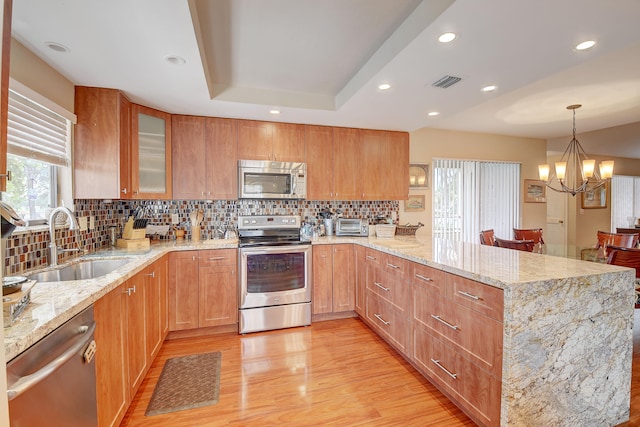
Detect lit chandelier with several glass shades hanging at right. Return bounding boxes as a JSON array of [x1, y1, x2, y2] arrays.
[[538, 104, 613, 196]]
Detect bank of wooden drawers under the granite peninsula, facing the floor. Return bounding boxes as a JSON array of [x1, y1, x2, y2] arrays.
[[356, 248, 504, 426]]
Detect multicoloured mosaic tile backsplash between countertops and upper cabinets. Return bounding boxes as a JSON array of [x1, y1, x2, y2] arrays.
[[4, 199, 399, 276]]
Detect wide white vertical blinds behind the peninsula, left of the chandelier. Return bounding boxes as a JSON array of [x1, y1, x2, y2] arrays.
[[433, 159, 520, 243]]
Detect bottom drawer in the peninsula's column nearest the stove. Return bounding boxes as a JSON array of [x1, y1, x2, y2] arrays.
[[366, 291, 409, 354]]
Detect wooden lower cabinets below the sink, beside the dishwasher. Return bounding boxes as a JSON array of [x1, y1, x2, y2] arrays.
[[94, 258, 168, 427]]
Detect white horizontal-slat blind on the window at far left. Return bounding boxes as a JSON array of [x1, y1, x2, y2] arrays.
[[7, 90, 70, 166]]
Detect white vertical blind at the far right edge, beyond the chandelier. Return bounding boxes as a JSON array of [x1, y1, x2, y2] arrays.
[[611, 175, 640, 231]]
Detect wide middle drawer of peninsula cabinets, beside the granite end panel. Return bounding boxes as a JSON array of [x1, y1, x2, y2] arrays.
[[413, 285, 503, 378]]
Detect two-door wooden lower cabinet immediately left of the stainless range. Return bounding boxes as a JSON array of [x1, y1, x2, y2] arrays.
[[169, 249, 238, 331]]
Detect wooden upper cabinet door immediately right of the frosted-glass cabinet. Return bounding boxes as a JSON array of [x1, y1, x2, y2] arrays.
[[171, 115, 206, 199]]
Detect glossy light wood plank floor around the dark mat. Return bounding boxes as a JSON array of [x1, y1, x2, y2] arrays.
[[121, 310, 640, 427]]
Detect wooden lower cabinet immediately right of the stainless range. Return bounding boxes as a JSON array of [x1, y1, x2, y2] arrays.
[[312, 244, 356, 314]]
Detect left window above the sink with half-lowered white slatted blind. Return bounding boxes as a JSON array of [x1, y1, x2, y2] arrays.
[[2, 81, 72, 225]]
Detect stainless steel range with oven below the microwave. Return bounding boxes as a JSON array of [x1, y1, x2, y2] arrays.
[[238, 215, 312, 334]]
